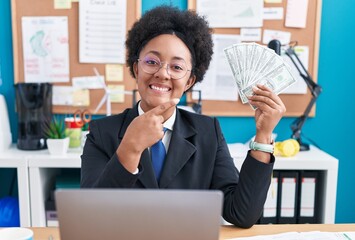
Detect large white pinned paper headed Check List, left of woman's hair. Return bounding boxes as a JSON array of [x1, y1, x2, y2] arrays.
[[79, 0, 129, 64]]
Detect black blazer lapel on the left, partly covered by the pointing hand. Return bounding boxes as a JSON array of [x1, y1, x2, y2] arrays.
[[118, 104, 158, 188]]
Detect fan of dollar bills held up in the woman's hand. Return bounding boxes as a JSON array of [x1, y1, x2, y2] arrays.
[[224, 43, 296, 109]]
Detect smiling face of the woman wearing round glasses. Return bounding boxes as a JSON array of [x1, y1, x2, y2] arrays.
[[134, 34, 195, 112]]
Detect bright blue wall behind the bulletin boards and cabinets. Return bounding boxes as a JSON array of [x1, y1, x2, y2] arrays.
[[0, 0, 355, 223]]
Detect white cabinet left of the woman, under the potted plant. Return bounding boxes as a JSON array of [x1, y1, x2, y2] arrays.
[[0, 145, 81, 227]]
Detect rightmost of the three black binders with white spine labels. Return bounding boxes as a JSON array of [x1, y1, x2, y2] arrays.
[[297, 171, 322, 223]]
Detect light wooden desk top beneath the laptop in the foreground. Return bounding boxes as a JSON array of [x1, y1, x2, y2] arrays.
[[31, 224, 355, 240]]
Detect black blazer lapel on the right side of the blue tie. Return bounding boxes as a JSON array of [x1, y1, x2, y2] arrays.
[[159, 109, 196, 188]]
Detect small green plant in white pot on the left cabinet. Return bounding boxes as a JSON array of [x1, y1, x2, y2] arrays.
[[44, 116, 69, 155]]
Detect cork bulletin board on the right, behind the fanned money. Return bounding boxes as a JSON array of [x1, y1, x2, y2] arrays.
[[188, 0, 322, 116]]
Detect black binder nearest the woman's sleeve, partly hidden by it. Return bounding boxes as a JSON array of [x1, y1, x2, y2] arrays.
[[259, 171, 279, 224]]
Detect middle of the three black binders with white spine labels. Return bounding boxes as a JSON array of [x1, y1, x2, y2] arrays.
[[278, 171, 299, 223]]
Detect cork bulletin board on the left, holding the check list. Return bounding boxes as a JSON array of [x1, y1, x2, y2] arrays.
[[11, 0, 141, 114]]
